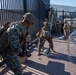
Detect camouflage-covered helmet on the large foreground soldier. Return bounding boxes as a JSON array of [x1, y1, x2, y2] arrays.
[[23, 13, 35, 25]]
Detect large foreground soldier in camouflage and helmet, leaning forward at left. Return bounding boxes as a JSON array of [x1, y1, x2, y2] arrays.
[[0, 13, 35, 75]]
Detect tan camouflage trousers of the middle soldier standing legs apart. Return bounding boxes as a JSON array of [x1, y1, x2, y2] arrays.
[[38, 37, 53, 54]]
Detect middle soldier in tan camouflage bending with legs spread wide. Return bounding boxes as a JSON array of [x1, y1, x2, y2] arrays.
[[37, 19, 55, 55]]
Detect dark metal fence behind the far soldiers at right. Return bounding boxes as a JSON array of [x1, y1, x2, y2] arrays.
[[48, 9, 76, 33]]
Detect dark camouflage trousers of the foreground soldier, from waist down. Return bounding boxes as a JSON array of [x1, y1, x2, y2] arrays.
[[0, 47, 23, 75]]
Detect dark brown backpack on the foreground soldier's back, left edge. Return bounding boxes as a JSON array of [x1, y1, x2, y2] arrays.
[[0, 22, 10, 47]]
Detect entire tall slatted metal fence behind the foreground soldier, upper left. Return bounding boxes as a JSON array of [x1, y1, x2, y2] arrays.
[[0, 0, 48, 37]]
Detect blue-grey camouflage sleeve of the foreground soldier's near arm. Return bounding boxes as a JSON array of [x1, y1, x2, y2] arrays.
[[8, 24, 22, 53]]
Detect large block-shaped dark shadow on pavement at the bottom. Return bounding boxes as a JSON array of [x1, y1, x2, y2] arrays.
[[25, 60, 70, 75]]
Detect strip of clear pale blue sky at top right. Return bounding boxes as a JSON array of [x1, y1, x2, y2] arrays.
[[50, 0, 76, 7]]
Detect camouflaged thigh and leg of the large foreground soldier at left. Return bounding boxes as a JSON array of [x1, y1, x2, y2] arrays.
[[4, 55, 23, 75]]
